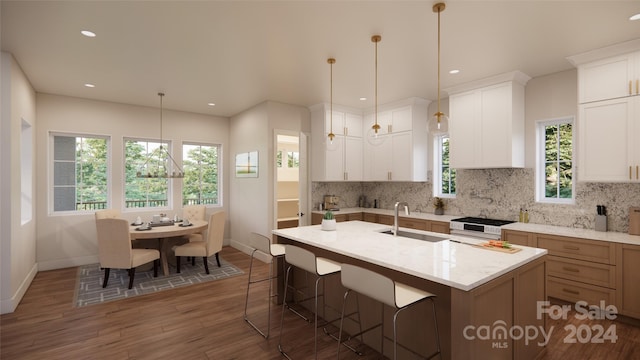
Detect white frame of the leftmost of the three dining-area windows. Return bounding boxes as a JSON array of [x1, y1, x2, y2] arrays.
[[47, 131, 113, 216]]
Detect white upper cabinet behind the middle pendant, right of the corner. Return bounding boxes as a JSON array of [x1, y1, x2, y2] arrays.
[[364, 98, 429, 181]]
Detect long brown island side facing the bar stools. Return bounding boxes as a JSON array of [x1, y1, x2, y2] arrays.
[[277, 236, 452, 359]]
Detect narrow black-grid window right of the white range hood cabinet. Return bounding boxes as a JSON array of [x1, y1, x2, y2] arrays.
[[536, 118, 575, 203]]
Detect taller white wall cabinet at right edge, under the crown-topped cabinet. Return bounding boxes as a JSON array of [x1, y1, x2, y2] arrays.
[[577, 97, 640, 182]]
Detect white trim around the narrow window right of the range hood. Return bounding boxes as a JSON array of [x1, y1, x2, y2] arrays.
[[535, 116, 576, 205]]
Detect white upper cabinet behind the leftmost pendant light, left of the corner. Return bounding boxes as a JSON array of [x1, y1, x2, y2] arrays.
[[311, 104, 363, 181]]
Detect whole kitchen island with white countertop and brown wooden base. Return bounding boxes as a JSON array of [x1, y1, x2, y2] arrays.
[[274, 221, 547, 359]]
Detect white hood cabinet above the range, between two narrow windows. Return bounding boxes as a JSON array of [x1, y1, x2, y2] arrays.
[[446, 71, 530, 169]]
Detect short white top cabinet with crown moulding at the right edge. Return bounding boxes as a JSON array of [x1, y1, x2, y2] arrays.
[[568, 40, 640, 104]]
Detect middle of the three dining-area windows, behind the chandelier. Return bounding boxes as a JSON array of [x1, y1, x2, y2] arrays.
[[124, 139, 171, 208]]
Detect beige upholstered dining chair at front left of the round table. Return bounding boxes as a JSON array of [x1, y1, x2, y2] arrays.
[[96, 218, 160, 289]]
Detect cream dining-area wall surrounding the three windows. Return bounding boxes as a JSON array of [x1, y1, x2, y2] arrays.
[[36, 94, 230, 270]]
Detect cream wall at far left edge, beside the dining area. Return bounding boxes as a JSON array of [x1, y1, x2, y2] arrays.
[[0, 52, 38, 313]]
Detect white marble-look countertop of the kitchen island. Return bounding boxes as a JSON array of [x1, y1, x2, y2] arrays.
[[273, 221, 547, 291]]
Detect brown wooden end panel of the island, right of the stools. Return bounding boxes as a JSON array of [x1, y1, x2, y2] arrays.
[[451, 257, 546, 360]]
